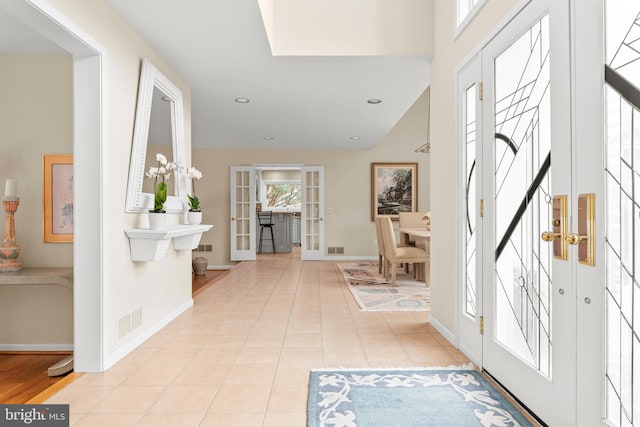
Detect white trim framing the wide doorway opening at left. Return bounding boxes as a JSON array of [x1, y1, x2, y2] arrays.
[[0, 0, 108, 372]]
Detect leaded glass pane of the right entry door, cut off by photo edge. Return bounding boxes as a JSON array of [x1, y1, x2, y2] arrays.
[[603, 0, 640, 426]]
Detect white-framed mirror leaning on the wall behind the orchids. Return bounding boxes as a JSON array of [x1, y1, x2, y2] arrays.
[[126, 59, 187, 213]]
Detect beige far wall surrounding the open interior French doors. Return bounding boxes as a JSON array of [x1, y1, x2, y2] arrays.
[[193, 88, 430, 266]]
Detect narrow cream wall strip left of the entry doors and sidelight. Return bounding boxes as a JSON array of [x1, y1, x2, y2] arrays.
[[430, 0, 518, 332]]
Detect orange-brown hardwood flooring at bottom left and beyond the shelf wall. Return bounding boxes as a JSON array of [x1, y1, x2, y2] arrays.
[[0, 270, 230, 404]]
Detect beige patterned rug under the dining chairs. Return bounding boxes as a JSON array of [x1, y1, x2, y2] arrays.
[[338, 262, 431, 311]]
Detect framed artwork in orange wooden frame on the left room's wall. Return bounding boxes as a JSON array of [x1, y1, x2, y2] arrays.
[[42, 154, 73, 242]]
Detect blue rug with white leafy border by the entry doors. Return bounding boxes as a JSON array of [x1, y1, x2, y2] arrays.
[[307, 368, 532, 427]]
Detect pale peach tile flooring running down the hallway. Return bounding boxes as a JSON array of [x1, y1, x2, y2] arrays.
[[47, 252, 469, 427]]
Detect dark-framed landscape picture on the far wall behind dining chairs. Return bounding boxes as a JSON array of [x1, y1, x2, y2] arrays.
[[371, 163, 418, 221]]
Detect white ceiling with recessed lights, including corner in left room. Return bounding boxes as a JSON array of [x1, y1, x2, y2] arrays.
[[0, 0, 429, 149]]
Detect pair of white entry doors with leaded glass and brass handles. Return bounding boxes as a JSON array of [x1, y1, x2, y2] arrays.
[[458, 0, 640, 426]]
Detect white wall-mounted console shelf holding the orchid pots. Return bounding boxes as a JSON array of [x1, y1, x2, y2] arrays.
[[124, 224, 213, 261]]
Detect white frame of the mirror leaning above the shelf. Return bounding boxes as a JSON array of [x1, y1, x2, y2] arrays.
[[125, 59, 187, 213]]
